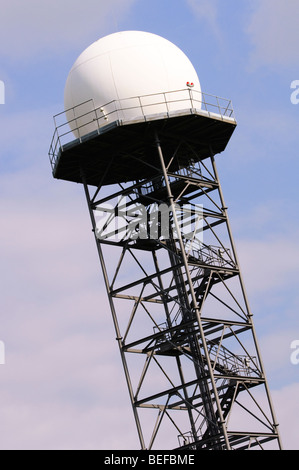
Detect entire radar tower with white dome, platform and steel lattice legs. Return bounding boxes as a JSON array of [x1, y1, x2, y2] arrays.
[[49, 32, 281, 451]]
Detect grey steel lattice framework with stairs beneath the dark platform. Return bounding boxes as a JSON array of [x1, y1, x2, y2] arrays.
[[49, 90, 281, 450]]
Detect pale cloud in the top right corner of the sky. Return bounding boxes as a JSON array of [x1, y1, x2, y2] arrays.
[[247, 0, 299, 66]]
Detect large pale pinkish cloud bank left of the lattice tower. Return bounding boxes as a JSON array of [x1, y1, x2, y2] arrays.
[[0, 164, 138, 449]]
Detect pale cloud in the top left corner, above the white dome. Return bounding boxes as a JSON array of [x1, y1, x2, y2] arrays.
[[0, 0, 136, 60]]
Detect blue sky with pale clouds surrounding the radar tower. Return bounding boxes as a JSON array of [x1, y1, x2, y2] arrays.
[[0, 0, 299, 449]]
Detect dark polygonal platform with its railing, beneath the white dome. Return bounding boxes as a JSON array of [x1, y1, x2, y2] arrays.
[[49, 90, 237, 186]]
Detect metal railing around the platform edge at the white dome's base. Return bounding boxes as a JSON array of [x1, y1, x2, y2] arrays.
[[49, 88, 235, 169]]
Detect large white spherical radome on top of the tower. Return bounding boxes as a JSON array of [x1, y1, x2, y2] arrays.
[[64, 31, 201, 137]]
